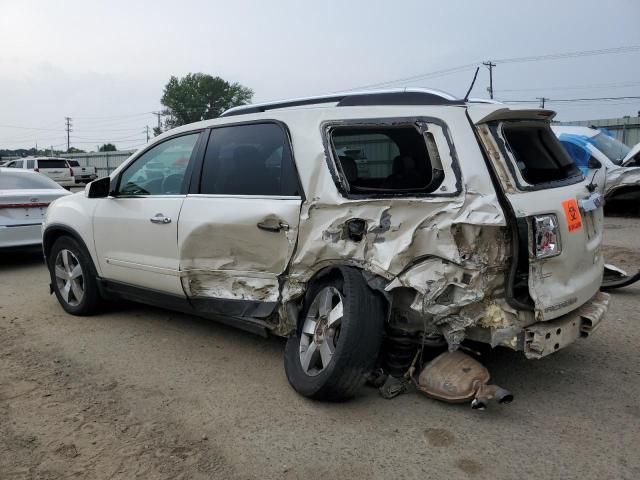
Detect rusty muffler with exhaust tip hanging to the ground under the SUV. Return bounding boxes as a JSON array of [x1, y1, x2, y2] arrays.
[[414, 350, 513, 410]]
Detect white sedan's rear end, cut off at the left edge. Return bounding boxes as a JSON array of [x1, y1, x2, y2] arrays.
[[0, 167, 71, 249]]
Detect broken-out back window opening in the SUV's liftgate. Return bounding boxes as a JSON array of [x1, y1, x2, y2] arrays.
[[502, 121, 581, 185]]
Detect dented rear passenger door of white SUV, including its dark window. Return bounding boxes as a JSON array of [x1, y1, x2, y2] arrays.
[[178, 122, 302, 317]]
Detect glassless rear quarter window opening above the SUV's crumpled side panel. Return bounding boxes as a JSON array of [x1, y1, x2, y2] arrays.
[[330, 126, 444, 195]]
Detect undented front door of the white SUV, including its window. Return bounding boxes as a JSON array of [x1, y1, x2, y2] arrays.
[[93, 132, 200, 296]]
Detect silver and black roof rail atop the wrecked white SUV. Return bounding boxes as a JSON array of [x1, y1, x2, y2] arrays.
[[221, 88, 465, 117]]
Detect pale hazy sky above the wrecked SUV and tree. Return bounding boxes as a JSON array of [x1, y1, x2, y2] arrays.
[[0, 0, 640, 150]]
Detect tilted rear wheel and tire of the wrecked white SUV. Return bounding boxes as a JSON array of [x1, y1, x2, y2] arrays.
[[284, 268, 385, 401]]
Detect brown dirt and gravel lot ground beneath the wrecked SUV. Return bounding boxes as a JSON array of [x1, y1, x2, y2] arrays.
[[0, 218, 640, 480]]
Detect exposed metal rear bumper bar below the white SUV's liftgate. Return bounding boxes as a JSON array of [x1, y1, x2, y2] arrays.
[[518, 292, 609, 358]]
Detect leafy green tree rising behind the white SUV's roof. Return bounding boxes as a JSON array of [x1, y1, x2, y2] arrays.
[[154, 73, 253, 135]]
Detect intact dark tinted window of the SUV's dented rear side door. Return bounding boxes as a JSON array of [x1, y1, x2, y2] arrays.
[[200, 123, 300, 196]]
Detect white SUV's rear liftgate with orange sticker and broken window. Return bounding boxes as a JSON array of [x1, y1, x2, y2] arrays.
[[470, 109, 604, 320]]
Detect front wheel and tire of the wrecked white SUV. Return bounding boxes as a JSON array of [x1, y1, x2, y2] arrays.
[[48, 236, 100, 315]]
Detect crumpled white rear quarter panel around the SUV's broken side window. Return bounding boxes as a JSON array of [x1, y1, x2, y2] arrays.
[[282, 108, 516, 348]]
